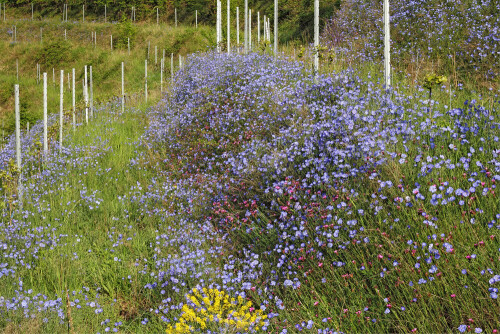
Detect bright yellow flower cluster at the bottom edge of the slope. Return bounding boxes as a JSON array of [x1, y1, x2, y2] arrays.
[[167, 288, 267, 334]]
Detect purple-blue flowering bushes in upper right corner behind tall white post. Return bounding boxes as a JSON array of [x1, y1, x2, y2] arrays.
[[323, 0, 500, 80]]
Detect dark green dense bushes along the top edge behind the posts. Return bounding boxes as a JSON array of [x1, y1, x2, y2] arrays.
[[4, 0, 340, 42]]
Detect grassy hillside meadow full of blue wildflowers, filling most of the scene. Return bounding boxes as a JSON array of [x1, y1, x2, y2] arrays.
[[0, 1, 500, 334]]
